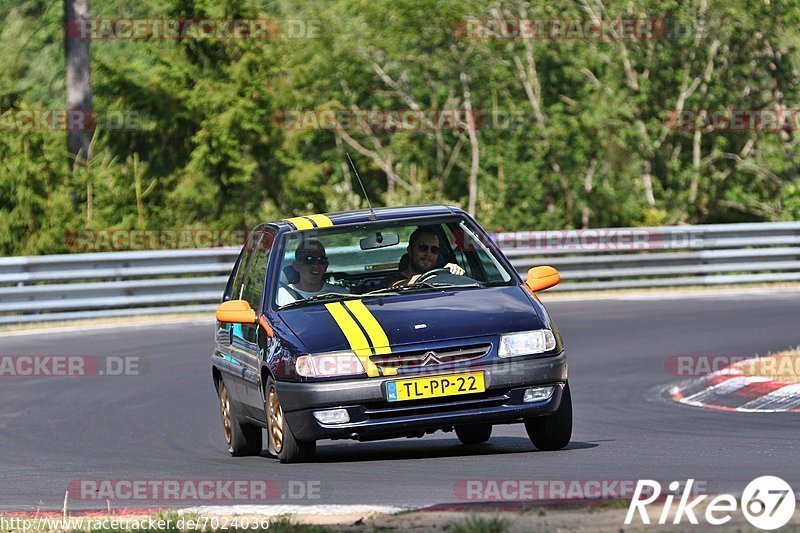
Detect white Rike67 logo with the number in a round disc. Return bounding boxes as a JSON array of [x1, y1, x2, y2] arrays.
[[625, 476, 796, 530]]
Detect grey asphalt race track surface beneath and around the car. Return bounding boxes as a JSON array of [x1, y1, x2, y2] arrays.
[[0, 292, 800, 510]]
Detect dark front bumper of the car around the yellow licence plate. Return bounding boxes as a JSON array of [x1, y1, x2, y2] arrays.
[[278, 352, 567, 440]]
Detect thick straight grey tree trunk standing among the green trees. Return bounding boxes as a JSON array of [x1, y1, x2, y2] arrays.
[[64, 0, 94, 168]]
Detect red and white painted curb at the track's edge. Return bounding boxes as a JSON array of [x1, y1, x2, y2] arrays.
[[668, 366, 800, 413]]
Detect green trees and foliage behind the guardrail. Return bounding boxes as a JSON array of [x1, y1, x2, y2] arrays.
[[0, 0, 800, 255]]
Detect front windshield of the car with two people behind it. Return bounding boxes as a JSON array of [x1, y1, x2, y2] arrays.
[[273, 217, 516, 308]]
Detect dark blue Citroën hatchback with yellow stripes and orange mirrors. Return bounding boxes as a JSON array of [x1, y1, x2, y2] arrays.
[[212, 206, 572, 463]]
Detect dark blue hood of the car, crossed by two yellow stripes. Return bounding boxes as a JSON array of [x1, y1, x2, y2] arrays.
[[279, 286, 544, 353]]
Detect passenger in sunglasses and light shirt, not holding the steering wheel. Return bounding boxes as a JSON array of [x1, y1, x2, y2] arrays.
[[278, 239, 350, 306]]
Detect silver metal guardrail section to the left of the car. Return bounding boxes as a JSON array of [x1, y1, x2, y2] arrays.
[[0, 248, 239, 324]]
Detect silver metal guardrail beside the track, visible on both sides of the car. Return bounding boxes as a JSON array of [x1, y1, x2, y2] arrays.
[[0, 222, 800, 324]]
